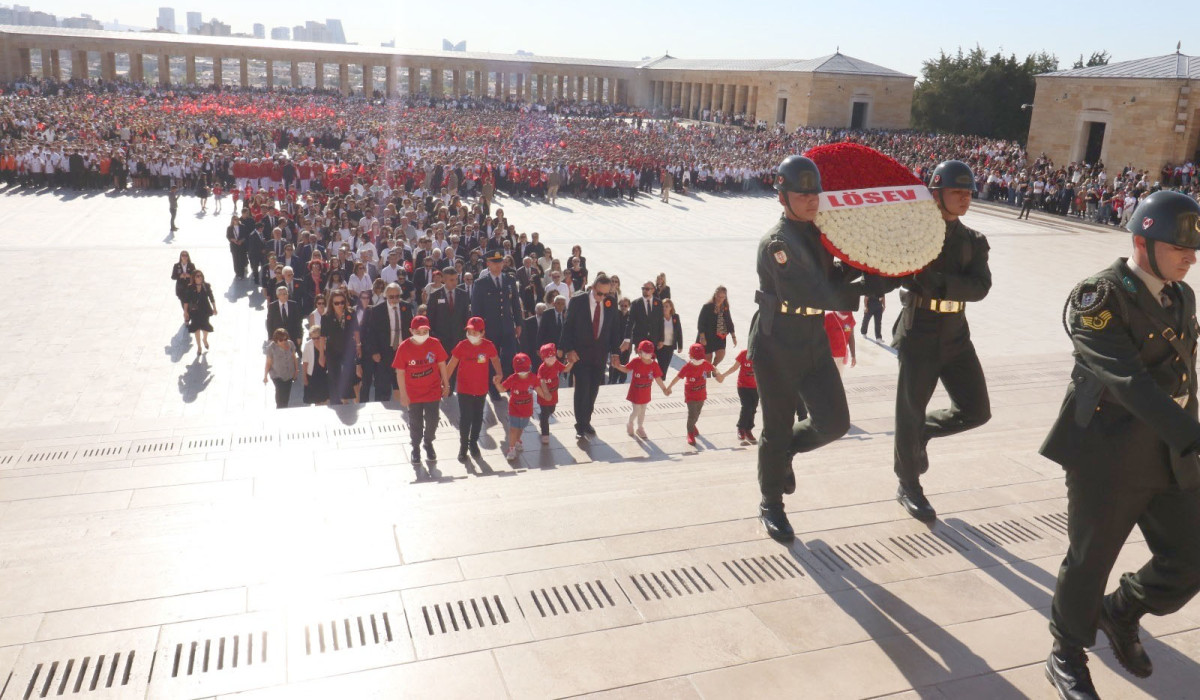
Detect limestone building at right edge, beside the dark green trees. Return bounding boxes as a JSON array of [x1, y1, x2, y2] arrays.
[[1028, 53, 1200, 172]]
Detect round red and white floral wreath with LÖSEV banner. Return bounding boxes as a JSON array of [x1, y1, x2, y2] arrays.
[[804, 143, 946, 277]]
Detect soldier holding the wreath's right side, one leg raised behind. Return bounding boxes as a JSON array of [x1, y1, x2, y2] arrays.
[[892, 161, 991, 522]]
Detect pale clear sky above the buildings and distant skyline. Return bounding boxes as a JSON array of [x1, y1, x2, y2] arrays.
[[32, 0, 1200, 76]]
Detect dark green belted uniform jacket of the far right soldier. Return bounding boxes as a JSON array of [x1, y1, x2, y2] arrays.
[[1042, 258, 1200, 489]]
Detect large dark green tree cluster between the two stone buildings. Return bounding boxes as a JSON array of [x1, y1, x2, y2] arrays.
[[912, 46, 1058, 140]]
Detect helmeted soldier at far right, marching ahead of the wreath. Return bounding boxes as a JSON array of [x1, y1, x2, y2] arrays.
[[1042, 191, 1200, 700]]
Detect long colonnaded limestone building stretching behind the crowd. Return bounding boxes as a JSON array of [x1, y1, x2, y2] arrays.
[[0, 25, 916, 130]]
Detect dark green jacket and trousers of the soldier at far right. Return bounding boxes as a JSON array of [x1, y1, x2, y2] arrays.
[[1042, 258, 1200, 648]]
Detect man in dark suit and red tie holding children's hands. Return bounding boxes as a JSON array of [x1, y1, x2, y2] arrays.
[[558, 273, 622, 439]]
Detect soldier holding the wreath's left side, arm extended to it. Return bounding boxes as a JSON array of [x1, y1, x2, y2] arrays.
[[748, 156, 864, 543]]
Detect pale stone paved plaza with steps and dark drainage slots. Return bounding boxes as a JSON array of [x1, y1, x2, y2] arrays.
[[0, 187, 1200, 700]]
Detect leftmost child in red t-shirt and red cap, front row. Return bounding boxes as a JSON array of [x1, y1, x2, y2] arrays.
[[391, 316, 450, 468]]
